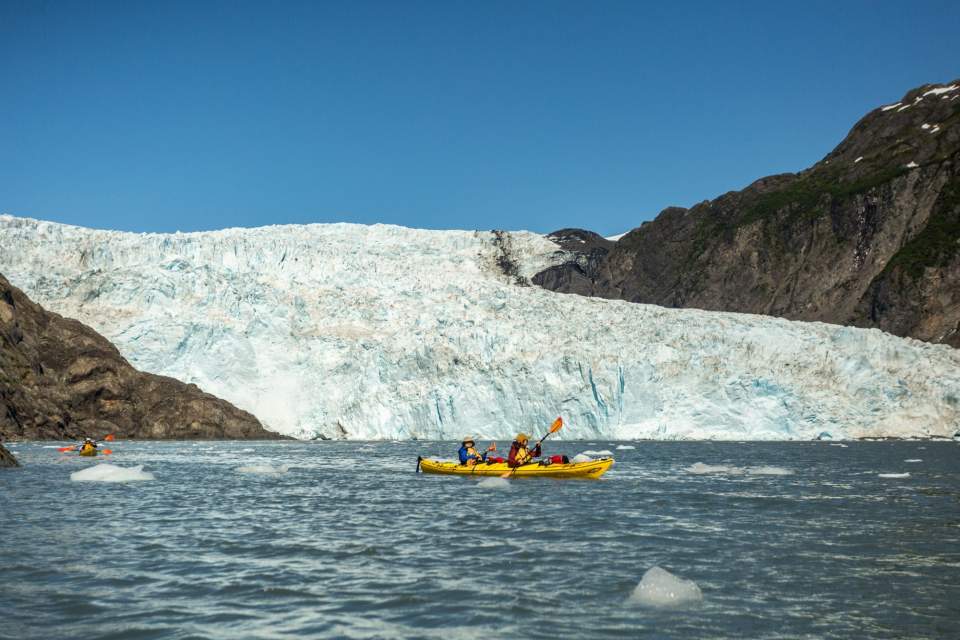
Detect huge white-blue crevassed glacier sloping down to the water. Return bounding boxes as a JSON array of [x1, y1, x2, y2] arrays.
[[0, 215, 960, 440]]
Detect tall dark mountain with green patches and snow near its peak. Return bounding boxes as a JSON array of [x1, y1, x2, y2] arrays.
[[533, 80, 960, 347]]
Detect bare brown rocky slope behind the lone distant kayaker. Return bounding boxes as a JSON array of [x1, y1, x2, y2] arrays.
[[0, 275, 279, 439]]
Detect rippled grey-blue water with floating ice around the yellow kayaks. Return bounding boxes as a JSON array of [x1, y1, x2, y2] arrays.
[[0, 442, 960, 639]]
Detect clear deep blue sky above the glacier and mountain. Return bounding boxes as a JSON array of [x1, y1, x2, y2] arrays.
[[0, 0, 960, 234]]
